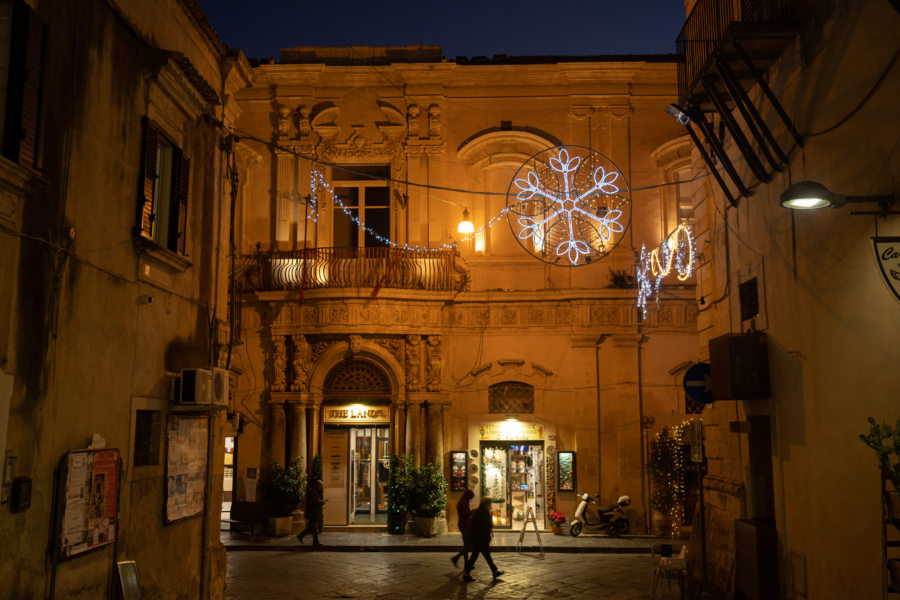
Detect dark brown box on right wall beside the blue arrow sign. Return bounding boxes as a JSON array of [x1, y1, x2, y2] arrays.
[[709, 333, 771, 400]]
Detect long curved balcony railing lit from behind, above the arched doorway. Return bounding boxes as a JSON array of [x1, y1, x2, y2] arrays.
[[235, 248, 468, 292]]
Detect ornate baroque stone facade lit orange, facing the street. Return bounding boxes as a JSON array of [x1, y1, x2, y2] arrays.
[[233, 47, 697, 529]]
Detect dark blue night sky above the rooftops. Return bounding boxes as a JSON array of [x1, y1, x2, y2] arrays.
[[199, 0, 685, 60]]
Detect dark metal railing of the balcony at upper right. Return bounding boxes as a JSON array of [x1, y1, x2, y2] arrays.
[[675, 0, 794, 102]]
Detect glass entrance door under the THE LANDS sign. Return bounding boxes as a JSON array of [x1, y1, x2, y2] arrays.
[[350, 427, 390, 523]]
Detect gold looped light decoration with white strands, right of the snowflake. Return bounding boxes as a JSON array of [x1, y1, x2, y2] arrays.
[[637, 223, 695, 317]]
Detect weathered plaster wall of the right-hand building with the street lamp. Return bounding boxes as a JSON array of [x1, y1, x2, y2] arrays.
[[695, 1, 900, 599]]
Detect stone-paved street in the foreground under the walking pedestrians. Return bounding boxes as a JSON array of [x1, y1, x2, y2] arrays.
[[226, 551, 678, 600]]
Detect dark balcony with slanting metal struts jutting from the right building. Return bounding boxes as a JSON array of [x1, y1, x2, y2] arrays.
[[670, 0, 803, 206]]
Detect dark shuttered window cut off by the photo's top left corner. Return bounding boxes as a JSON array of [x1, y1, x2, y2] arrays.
[[0, 0, 45, 171]]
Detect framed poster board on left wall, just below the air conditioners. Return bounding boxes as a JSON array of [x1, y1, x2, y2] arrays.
[[166, 415, 209, 523]]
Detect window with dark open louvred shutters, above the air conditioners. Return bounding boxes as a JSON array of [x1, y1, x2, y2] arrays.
[[138, 119, 191, 255]]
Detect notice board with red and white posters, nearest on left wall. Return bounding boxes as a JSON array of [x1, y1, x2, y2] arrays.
[[56, 448, 119, 559]]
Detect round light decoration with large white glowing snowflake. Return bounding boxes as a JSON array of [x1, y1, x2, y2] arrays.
[[507, 146, 631, 267]]
